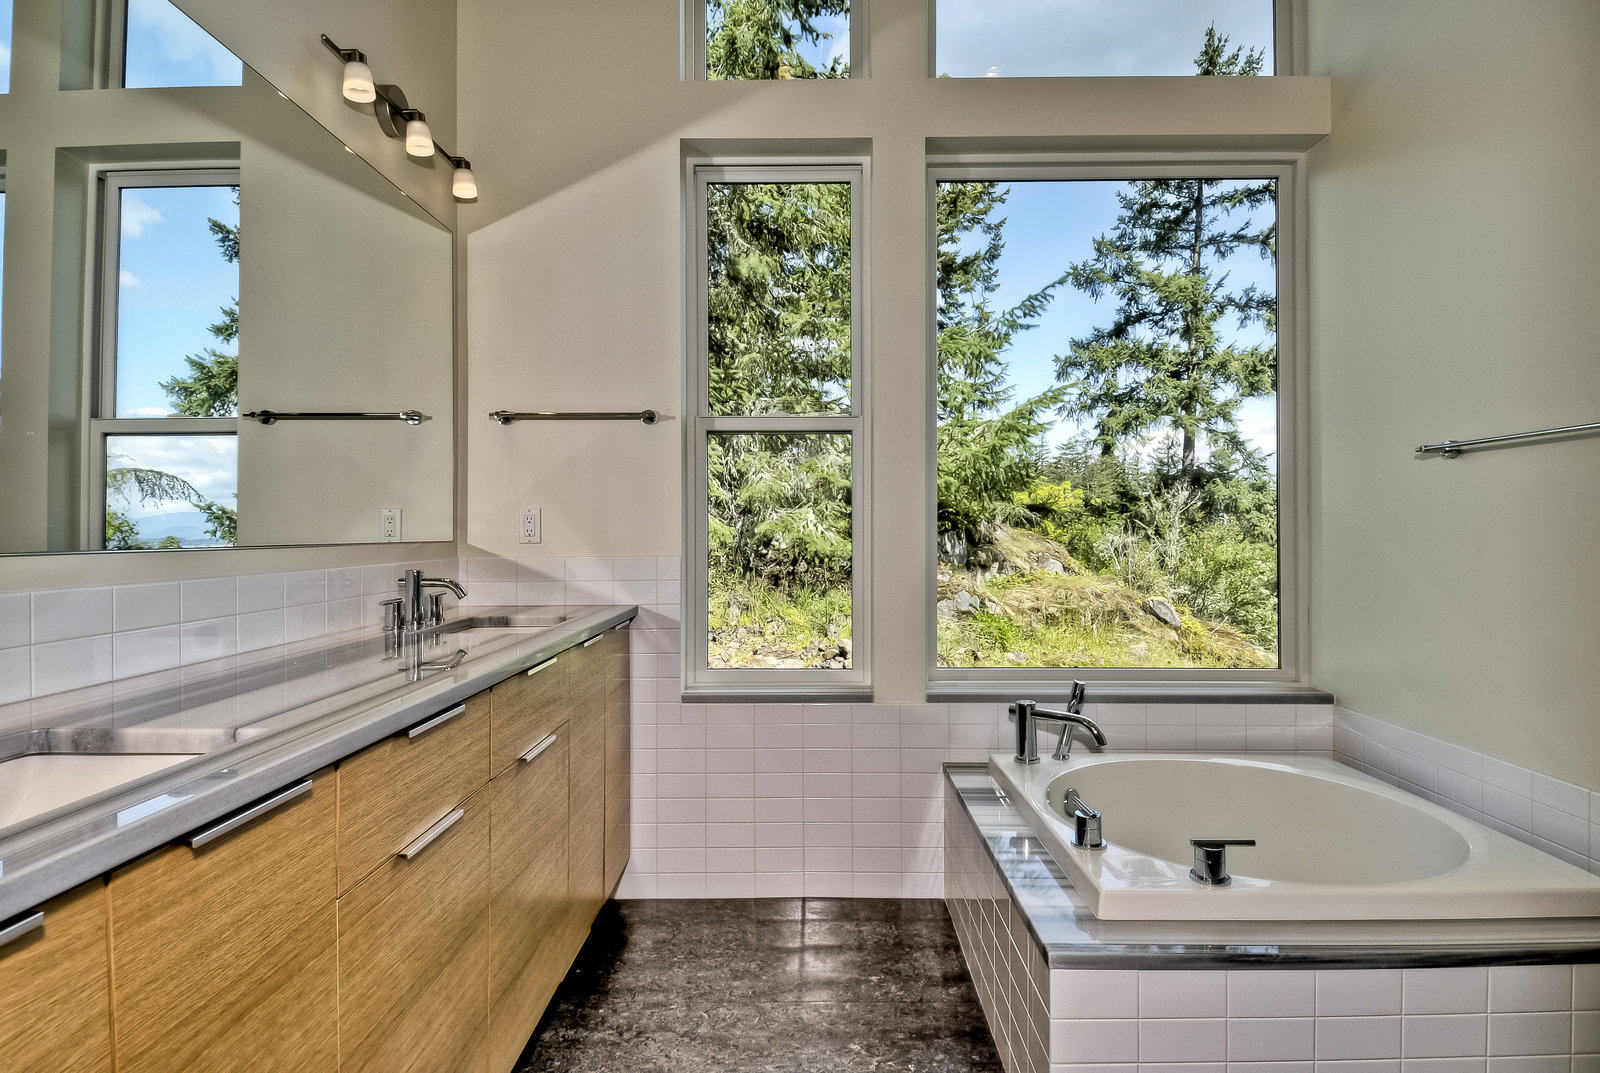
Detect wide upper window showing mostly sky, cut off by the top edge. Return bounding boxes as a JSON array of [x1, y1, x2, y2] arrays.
[[933, 0, 1286, 78]]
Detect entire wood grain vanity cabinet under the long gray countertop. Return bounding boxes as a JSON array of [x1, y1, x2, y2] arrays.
[[17, 628, 630, 1073]]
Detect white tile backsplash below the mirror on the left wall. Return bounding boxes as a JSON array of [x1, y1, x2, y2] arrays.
[[0, 560, 464, 704]]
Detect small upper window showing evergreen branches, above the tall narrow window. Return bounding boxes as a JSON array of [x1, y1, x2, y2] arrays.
[[683, 0, 866, 82]]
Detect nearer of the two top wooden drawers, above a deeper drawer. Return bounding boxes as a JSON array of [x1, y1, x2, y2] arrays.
[[339, 692, 490, 895]]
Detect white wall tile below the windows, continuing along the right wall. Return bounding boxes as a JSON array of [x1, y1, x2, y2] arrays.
[[456, 555, 1600, 897]]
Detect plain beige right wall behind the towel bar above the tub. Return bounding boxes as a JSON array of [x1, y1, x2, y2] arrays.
[[1309, 0, 1600, 787]]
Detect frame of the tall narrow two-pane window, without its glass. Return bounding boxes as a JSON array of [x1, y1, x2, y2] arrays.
[[680, 157, 872, 700]]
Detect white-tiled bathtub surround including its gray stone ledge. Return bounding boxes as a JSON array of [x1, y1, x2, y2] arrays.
[[946, 769, 1600, 1073]]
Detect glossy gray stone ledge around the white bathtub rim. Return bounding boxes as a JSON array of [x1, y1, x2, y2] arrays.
[[944, 764, 1600, 969]]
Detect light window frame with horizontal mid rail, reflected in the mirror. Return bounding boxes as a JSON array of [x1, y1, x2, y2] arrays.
[[80, 167, 242, 552]]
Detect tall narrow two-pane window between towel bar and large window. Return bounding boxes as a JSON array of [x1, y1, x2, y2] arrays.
[[685, 163, 869, 692]]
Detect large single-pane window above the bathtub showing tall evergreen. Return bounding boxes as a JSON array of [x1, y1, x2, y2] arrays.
[[931, 162, 1298, 681]]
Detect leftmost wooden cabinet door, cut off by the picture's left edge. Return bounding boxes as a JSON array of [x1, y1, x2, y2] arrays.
[[0, 880, 110, 1073]]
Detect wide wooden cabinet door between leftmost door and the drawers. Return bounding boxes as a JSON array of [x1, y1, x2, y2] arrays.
[[109, 771, 338, 1073]]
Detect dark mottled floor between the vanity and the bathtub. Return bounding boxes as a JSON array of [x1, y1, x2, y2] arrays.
[[517, 899, 1000, 1073]]
